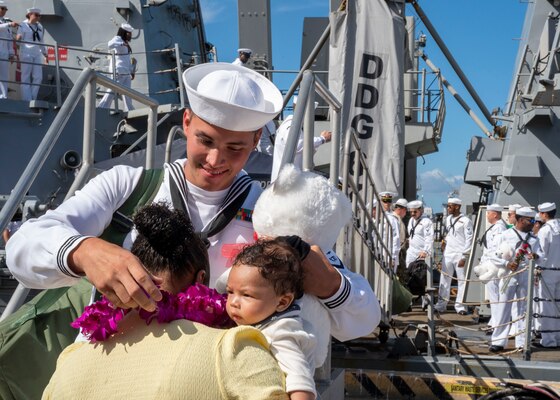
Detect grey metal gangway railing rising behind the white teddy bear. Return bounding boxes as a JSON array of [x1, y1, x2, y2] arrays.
[[280, 70, 394, 318]]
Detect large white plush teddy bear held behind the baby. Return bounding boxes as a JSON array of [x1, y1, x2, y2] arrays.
[[216, 164, 352, 368]]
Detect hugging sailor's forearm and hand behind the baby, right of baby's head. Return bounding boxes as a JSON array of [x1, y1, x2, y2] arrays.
[[303, 246, 381, 341]]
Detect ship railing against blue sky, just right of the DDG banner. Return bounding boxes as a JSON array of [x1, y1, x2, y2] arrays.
[[404, 68, 446, 143]]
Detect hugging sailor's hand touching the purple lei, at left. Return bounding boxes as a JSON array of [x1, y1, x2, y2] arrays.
[[68, 238, 162, 311]]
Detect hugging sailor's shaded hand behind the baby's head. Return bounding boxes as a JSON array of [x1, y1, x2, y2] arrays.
[[302, 245, 342, 299]]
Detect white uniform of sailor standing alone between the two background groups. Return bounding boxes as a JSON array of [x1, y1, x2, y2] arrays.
[[435, 214, 473, 313]]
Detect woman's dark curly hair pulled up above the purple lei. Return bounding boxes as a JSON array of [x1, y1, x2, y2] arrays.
[[131, 203, 209, 279]]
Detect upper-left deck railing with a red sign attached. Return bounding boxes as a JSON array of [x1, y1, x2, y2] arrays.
[[0, 38, 188, 109]]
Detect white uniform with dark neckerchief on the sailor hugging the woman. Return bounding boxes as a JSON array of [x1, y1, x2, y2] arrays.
[[6, 160, 380, 341]]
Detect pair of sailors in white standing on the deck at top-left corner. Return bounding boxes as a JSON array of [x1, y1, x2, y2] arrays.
[[0, 0, 48, 101]]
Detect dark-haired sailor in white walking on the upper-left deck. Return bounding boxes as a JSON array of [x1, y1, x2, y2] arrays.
[[98, 24, 136, 111]]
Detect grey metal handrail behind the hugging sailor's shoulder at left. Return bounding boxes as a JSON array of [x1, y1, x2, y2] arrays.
[[0, 68, 159, 320]]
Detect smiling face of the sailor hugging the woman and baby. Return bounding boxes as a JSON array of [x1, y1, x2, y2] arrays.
[[183, 111, 261, 191]]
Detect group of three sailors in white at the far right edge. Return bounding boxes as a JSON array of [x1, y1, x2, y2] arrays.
[[481, 202, 560, 353]]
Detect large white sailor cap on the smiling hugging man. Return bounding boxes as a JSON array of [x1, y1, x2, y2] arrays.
[[183, 63, 283, 132]]
